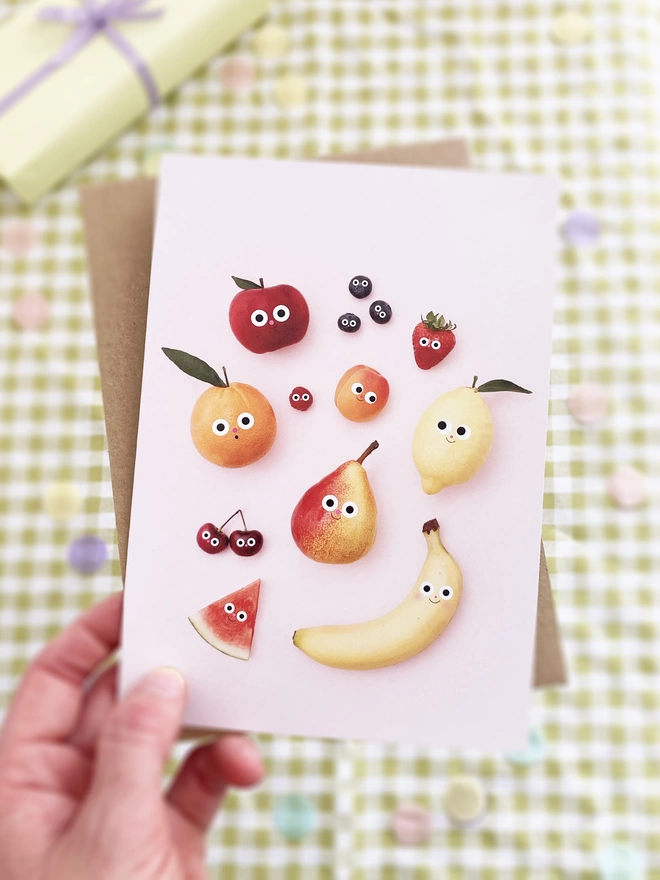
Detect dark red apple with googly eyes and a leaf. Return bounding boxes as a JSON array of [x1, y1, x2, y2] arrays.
[[229, 275, 309, 354]]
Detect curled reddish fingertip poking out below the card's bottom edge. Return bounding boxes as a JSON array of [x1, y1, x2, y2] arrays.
[[167, 734, 264, 831]]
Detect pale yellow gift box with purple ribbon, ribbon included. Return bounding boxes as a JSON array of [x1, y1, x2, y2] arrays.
[[0, 0, 269, 202]]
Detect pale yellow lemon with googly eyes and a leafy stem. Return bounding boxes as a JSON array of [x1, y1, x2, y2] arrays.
[[413, 376, 532, 495]]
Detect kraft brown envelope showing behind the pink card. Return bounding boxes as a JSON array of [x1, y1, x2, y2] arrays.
[[82, 140, 566, 687]]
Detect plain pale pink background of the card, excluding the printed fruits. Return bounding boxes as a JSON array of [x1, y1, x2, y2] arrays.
[[122, 156, 557, 749]]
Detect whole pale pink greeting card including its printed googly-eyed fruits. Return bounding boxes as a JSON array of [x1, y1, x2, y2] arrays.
[[122, 156, 556, 748]]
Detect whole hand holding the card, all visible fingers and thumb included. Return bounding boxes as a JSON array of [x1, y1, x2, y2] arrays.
[[0, 594, 263, 880]]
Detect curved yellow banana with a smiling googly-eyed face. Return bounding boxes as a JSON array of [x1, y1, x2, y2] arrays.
[[293, 519, 463, 669]]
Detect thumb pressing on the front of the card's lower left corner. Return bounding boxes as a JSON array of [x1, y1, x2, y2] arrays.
[[90, 666, 187, 804]]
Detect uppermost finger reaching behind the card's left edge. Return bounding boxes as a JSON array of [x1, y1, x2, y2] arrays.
[[2, 593, 122, 746]]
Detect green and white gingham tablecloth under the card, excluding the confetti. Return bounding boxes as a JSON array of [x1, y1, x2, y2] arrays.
[[0, 0, 660, 880]]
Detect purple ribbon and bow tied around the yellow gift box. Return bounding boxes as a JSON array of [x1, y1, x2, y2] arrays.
[[0, 0, 164, 116]]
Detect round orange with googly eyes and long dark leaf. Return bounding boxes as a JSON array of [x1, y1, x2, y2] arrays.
[[163, 348, 277, 468]]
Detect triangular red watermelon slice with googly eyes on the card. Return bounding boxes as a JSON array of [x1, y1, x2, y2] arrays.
[[188, 580, 261, 660]]
